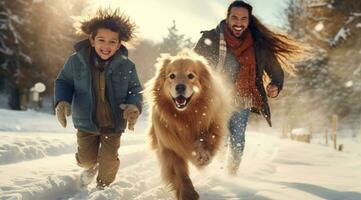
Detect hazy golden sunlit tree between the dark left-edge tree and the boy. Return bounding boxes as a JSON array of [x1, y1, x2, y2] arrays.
[[31, 0, 86, 94]]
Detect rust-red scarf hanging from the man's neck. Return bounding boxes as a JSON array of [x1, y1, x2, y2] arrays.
[[224, 26, 263, 108]]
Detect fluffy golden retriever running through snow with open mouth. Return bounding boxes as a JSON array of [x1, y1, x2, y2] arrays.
[[145, 50, 233, 200]]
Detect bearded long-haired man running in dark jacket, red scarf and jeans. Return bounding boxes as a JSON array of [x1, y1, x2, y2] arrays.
[[194, 1, 303, 175]]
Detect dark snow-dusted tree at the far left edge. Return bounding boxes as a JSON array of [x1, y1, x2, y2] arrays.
[[0, 0, 32, 110]]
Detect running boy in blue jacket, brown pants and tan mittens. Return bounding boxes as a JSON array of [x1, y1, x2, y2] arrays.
[[55, 9, 142, 189]]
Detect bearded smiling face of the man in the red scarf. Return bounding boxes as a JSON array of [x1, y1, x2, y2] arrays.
[[226, 7, 249, 37]]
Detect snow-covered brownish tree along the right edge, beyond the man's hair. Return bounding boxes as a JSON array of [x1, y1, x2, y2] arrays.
[[278, 0, 361, 134]]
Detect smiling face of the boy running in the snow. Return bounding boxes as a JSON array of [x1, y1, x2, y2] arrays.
[[89, 28, 121, 60]]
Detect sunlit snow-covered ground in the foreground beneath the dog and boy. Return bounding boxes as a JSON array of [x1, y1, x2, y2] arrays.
[[0, 132, 361, 200]]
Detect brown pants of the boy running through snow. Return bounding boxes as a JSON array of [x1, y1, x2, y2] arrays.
[[75, 130, 120, 186]]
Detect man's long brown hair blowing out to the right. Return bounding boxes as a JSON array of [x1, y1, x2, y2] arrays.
[[227, 1, 310, 75]]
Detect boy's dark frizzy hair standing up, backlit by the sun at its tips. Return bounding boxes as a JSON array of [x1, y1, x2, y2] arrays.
[[79, 8, 136, 42]]
